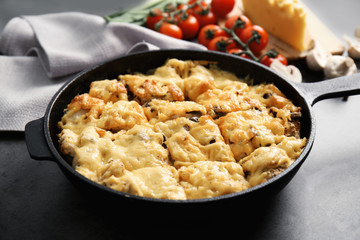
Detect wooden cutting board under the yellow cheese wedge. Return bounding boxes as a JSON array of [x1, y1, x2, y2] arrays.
[[225, 0, 345, 61]]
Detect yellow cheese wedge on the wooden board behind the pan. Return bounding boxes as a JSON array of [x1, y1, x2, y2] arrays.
[[242, 0, 312, 52]]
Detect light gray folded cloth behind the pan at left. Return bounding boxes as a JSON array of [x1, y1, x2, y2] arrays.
[[0, 12, 205, 131]]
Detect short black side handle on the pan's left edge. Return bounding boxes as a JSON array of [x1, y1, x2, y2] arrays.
[[25, 118, 55, 161]]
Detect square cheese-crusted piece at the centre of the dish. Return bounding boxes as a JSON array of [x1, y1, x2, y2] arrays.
[[155, 115, 235, 168]]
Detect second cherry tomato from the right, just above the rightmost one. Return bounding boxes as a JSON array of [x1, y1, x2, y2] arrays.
[[238, 25, 269, 55]]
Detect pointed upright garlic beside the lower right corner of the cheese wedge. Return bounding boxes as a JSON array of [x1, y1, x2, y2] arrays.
[[306, 41, 331, 71]]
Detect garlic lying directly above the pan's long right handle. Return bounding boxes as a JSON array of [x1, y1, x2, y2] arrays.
[[324, 55, 357, 78]]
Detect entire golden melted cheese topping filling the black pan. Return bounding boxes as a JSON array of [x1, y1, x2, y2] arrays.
[[58, 59, 306, 199]]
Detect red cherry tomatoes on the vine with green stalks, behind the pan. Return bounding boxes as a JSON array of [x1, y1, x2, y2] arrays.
[[105, 0, 287, 66]]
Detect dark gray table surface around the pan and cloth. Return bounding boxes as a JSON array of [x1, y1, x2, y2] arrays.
[[0, 0, 360, 239]]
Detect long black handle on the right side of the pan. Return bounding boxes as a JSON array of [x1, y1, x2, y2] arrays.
[[295, 73, 360, 106]]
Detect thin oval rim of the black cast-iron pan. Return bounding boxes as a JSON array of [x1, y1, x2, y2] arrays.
[[44, 49, 315, 205]]
